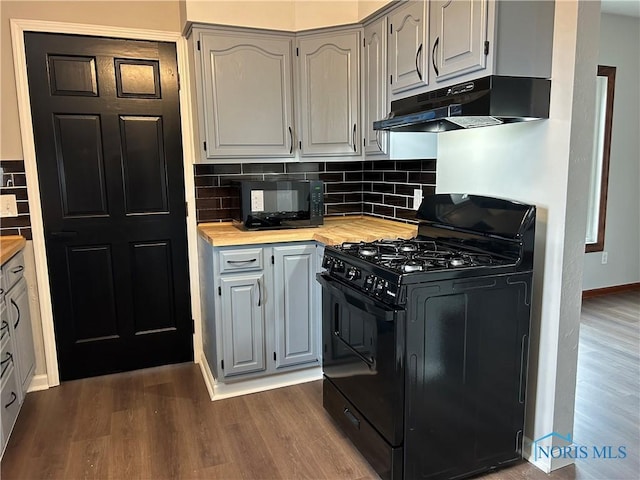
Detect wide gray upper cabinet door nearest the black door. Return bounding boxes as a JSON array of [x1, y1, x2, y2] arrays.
[[200, 33, 294, 158]]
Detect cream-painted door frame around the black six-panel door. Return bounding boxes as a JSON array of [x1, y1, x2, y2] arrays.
[[10, 19, 202, 390]]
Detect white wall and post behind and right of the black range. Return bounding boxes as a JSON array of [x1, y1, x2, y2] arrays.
[[437, 0, 600, 472]]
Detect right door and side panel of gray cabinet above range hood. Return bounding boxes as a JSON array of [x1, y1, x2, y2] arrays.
[[429, 0, 555, 90]]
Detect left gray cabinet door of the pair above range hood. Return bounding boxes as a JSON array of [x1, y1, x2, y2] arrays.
[[389, 1, 429, 100]]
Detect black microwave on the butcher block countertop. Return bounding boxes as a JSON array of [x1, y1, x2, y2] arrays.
[[235, 180, 324, 230]]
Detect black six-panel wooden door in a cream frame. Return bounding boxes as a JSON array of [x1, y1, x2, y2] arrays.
[[25, 33, 193, 380]]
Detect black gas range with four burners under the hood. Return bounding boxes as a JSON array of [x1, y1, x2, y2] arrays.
[[318, 194, 535, 480]]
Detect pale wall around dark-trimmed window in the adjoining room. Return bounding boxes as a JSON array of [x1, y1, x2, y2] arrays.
[[582, 14, 640, 290]]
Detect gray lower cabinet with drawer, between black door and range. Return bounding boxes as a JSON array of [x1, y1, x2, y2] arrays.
[[199, 240, 320, 382]]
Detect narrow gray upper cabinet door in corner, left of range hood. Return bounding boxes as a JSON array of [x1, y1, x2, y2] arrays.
[[362, 18, 389, 157]]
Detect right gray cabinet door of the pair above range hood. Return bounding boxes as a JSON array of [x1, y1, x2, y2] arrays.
[[431, 0, 488, 81]]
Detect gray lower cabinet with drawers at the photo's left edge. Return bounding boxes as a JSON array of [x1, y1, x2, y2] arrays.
[[0, 252, 35, 460]]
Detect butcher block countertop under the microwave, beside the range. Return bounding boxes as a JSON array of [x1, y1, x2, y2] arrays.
[[198, 215, 417, 247]]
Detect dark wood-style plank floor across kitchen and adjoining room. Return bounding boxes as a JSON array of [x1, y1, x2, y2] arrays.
[[1, 291, 640, 480]]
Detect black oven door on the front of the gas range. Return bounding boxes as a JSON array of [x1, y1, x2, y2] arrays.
[[318, 274, 405, 447]]
